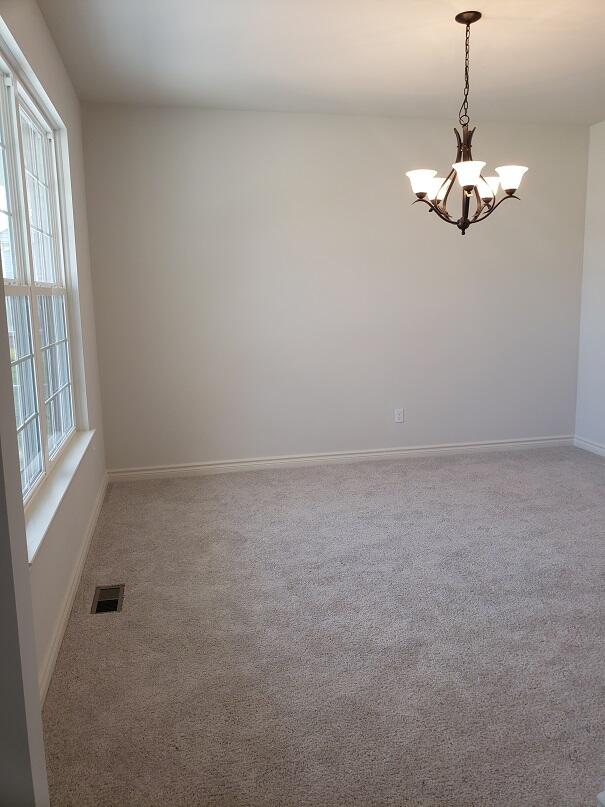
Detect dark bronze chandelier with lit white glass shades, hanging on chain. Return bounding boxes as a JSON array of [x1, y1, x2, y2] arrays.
[[406, 11, 527, 235]]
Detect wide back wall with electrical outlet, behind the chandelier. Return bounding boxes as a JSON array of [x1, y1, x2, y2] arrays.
[[84, 105, 587, 469]]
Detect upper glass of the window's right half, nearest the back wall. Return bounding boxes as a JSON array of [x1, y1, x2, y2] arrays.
[[19, 109, 60, 283]]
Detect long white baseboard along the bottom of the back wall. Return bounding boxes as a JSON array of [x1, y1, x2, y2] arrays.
[[107, 435, 573, 482]]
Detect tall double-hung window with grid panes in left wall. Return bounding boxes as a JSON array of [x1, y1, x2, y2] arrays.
[[0, 69, 75, 499]]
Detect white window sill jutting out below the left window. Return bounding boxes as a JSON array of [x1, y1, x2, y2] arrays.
[[25, 429, 95, 563]]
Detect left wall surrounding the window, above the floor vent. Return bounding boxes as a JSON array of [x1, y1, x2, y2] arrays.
[[0, 0, 105, 696]]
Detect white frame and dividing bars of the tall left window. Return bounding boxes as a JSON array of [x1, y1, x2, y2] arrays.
[[0, 51, 79, 508]]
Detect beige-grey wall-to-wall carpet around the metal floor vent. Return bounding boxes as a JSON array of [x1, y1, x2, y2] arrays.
[[44, 449, 605, 807]]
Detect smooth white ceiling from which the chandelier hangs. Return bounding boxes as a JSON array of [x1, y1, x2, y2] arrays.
[[39, 0, 605, 123]]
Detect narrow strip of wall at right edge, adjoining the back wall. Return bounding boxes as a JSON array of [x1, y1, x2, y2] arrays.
[[576, 122, 605, 454]]
